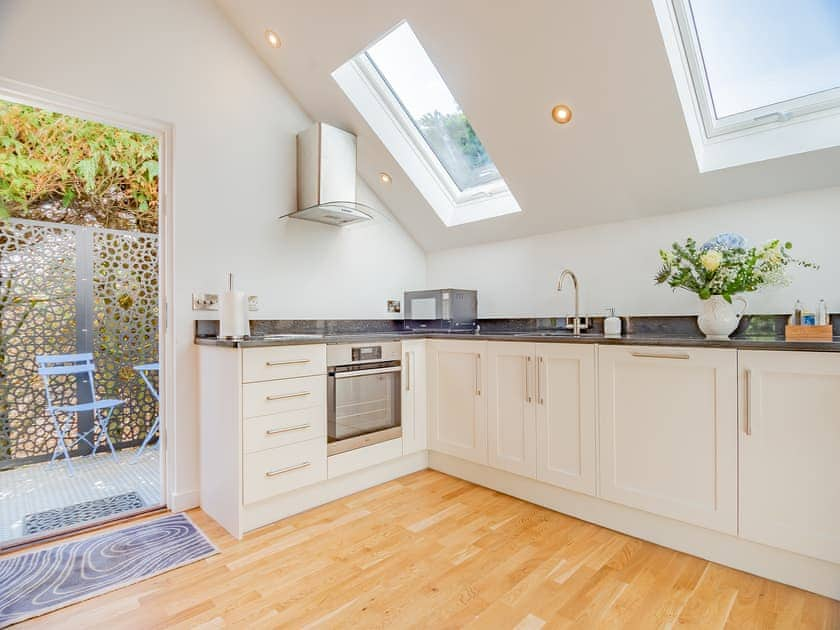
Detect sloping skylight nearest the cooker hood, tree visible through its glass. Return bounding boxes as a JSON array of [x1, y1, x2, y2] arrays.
[[333, 22, 520, 225]]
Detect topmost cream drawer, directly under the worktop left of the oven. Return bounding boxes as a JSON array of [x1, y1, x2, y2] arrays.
[[242, 344, 327, 383]]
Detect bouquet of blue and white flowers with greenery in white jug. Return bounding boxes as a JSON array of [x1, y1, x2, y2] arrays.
[[655, 234, 818, 302]]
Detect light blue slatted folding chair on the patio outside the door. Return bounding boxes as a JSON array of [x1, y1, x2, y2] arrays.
[[35, 353, 125, 477]]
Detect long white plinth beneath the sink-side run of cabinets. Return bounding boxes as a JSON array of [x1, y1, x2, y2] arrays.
[[429, 452, 840, 599]]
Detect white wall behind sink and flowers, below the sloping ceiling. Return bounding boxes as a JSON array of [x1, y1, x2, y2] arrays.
[[427, 188, 840, 317]]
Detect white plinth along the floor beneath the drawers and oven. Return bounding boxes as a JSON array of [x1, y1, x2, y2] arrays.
[[243, 451, 429, 532]]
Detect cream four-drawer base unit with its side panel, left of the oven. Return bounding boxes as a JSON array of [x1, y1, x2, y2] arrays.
[[199, 344, 327, 537]]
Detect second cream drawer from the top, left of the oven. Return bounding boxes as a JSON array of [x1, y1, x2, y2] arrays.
[[242, 376, 327, 418]]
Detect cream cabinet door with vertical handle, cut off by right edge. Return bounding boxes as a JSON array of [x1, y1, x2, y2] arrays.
[[739, 351, 840, 563]]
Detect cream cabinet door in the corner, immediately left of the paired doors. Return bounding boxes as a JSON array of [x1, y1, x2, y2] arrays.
[[426, 339, 487, 464]]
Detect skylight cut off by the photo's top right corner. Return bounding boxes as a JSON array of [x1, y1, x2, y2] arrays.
[[652, 0, 840, 171]]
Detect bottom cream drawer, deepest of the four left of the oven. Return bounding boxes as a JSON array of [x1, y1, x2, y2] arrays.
[[243, 437, 327, 504]]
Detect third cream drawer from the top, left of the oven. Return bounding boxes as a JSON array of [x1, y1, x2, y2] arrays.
[[245, 405, 327, 453]]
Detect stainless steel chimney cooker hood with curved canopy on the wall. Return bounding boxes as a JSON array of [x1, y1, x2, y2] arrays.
[[281, 122, 373, 227]]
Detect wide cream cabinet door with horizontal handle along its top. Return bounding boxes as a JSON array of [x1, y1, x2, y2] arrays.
[[599, 346, 738, 534]]
